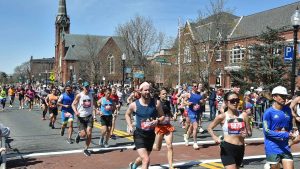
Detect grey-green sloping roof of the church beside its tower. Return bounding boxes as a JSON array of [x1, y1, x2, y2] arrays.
[[64, 34, 126, 60]]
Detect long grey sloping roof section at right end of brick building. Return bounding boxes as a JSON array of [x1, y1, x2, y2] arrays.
[[229, 2, 300, 39]]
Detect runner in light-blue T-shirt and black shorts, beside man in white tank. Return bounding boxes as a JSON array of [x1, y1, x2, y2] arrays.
[[97, 88, 116, 148]]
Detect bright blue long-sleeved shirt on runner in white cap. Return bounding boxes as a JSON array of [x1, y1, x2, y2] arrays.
[[263, 106, 293, 154]]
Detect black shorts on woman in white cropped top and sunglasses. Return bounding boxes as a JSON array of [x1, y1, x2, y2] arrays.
[[220, 141, 245, 166]]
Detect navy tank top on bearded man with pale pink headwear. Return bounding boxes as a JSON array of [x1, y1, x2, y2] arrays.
[[135, 99, 157, 131]]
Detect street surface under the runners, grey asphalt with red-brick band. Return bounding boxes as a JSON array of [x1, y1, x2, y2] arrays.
[[0, 102, 300, 169]]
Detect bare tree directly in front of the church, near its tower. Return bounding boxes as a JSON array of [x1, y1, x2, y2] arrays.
[[79, 35, 102, 83]]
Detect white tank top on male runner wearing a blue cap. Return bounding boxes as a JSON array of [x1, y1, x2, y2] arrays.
[[77, 92, 93, 117]]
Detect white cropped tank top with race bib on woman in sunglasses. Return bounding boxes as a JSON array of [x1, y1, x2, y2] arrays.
[[222, 112, 245, 135]]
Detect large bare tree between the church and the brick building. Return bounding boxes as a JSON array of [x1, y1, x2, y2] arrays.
[[116, 15, 166, 82]]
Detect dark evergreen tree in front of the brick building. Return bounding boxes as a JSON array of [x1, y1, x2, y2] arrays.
[[231, 27, 291, 89]]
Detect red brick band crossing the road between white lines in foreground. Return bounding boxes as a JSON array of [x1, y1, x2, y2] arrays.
[[7, 144, 300, 169]]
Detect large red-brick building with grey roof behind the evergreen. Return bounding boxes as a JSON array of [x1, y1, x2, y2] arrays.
[[173, 2, 300, 88]]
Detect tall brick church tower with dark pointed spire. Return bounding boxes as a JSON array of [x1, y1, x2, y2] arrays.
[[54, 0, 70, 82]]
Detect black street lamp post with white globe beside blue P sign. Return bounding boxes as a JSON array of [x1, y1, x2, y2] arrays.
[[291, 7, 300, 96]]
